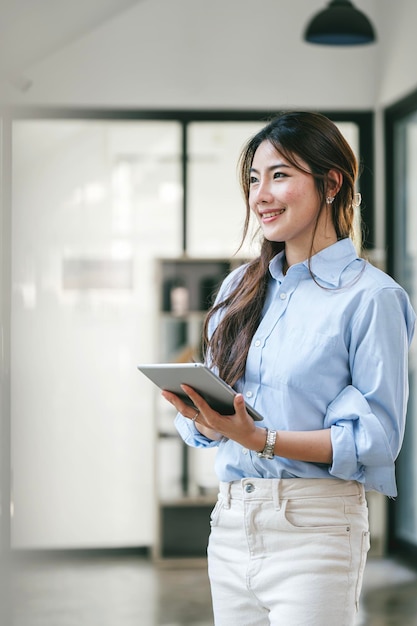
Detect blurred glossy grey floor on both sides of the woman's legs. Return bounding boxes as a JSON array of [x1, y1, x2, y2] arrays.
[[5, 555, 417, 626]]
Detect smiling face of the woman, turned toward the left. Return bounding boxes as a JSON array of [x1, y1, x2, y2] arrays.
[[249, 141, 337, 265]]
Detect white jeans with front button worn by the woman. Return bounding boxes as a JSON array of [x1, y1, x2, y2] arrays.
[[208, 478, 369, 626]]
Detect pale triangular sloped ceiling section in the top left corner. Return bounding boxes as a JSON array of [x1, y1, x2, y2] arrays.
[[0, 0, 141, 75]]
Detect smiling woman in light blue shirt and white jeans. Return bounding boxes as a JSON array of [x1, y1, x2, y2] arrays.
[[163, 112, 415, 626]]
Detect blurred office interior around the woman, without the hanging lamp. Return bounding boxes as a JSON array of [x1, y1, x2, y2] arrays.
[[0, 0, 417, 626]]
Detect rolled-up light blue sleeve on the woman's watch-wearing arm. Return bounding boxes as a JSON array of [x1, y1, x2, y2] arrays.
[[324, 289, 415, 497]]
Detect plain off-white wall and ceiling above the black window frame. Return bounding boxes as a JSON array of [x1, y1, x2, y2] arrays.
[[0, 0, 384, 110]]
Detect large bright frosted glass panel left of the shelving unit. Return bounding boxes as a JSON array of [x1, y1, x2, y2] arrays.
[[11, 120, 182, 548]]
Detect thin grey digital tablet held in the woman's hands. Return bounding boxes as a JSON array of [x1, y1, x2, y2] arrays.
[[138, 363, 263, 421]]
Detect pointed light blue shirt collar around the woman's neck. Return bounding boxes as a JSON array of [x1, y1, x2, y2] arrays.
[[269, 237, 358, 286]]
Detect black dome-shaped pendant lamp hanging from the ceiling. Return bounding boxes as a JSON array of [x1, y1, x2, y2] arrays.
[[304, 0, 375, 46]]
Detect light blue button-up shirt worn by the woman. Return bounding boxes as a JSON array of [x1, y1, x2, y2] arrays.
[[175, 239, 416, 496]]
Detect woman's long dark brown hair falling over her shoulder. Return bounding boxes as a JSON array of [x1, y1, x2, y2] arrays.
[[203, 111, 358, 385]]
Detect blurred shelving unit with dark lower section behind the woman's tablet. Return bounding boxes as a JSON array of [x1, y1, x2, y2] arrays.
[[154, 258, 237, 560]]
